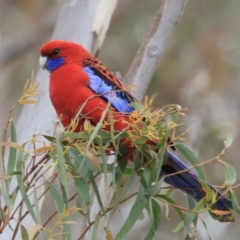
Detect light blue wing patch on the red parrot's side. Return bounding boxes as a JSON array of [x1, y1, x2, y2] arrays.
[[83, 67, 134, 113]]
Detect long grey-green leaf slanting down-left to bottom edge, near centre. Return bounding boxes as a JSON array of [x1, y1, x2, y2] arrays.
[[115, 186, 148, 240]]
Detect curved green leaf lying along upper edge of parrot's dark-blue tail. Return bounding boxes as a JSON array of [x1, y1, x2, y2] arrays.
[[174, 143, 205, 181]]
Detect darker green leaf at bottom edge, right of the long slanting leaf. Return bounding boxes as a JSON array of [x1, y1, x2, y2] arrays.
[[144, 198, 161, 240]]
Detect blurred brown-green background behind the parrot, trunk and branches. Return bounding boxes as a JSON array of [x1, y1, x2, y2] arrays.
[[0, 0, 240, 240]]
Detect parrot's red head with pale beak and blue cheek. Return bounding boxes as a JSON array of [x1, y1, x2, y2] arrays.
[[39, 40, 92, 72]]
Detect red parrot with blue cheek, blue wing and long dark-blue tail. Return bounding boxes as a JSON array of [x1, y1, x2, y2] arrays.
[[39, 40, 233, 221]]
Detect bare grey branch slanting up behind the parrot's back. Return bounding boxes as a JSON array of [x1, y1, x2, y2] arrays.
[[124, 0, 187, 100]]
